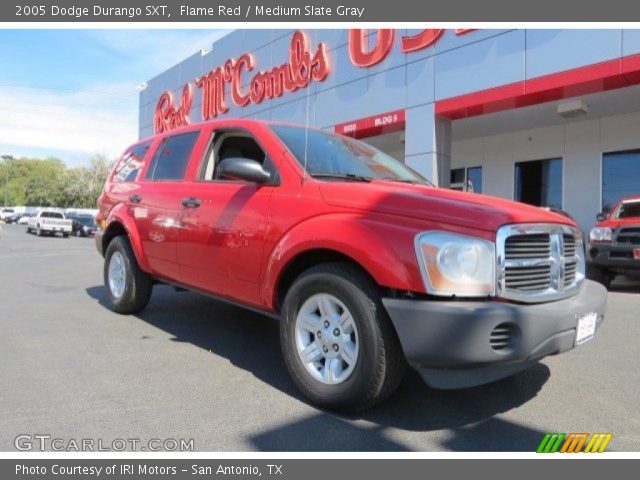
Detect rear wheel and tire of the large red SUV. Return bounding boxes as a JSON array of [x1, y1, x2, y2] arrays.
[[103, 236, 153, 314]]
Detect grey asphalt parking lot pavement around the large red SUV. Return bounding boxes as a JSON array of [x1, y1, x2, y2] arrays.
[[0, 225, 640, 451]]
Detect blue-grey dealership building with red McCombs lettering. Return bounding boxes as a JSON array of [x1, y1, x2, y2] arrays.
[[139, 29, 640, 229]]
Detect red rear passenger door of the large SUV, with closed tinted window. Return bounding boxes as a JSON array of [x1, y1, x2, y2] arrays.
[[136, 130, 200, 282]]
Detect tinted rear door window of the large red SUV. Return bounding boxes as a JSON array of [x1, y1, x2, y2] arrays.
[[147, 131, 200, 180]]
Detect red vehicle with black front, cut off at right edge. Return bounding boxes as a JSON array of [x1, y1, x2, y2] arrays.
[[588, 195, 640, 288]]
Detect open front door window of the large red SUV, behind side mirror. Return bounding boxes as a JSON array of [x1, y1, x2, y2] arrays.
[[200, 132, 273, 181]]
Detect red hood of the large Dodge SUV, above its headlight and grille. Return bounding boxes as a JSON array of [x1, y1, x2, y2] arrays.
[[318, 181, 576, 232]]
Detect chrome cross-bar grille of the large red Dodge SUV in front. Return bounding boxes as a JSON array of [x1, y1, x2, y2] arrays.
[[496, 224, 584, 302]]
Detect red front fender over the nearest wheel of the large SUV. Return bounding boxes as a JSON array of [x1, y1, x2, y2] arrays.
[[262, 213, 424, 307]]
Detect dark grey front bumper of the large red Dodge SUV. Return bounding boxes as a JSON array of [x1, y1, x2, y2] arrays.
[[382, 280, 607, 388]]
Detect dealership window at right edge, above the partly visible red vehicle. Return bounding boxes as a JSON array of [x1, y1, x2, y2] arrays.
[[602, 150, 640, 212]]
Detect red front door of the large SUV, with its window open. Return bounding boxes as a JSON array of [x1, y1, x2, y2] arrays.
[[178, 124, 277, 305]]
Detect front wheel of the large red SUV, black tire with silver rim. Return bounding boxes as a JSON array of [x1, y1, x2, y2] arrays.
[[280, 263, 406, 411]]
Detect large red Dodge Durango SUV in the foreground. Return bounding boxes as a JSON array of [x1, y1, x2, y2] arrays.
[[96, 120, 607, 410]]
